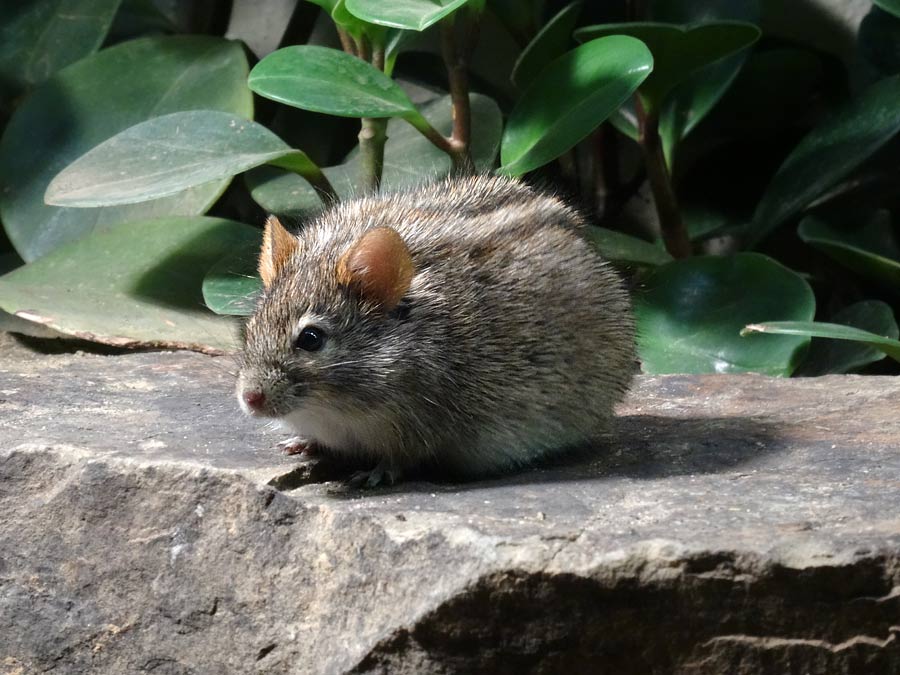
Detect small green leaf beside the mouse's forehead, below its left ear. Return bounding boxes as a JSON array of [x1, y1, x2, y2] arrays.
[[203, 238, 262, 316]]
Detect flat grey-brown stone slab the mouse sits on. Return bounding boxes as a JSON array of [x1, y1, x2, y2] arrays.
[[0, 339, 900, 675]]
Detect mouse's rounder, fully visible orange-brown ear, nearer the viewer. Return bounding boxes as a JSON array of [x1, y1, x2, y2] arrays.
[[337, 227, 413, 310]]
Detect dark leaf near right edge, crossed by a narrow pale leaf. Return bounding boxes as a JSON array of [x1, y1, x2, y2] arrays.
[[798, 300, 900, 375]]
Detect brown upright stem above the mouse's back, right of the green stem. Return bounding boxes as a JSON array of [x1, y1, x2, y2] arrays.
[[440, 12, 474, 173]]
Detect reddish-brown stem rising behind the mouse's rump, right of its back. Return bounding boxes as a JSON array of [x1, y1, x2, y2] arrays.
[[635, 97, 691, 258]]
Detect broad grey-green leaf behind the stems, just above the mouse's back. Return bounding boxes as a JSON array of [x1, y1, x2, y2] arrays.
[[247, 94, 503, 216]]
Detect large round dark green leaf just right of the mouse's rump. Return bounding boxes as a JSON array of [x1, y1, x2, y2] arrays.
[[635, 253, 815, 375]]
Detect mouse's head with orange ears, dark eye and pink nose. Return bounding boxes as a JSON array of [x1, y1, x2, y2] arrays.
[[237, 217, 414, 418]]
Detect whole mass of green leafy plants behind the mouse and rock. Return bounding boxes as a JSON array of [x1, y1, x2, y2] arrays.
[[0, 0, 900, 375]]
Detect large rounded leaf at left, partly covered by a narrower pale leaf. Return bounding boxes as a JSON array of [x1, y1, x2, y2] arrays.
[[0, 36, 253, 260]]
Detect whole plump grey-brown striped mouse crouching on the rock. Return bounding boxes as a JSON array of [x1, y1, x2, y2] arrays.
[[237, 175, 635, 487]]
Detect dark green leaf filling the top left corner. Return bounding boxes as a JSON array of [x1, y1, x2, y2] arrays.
[[0, 0, 121, 105]]
